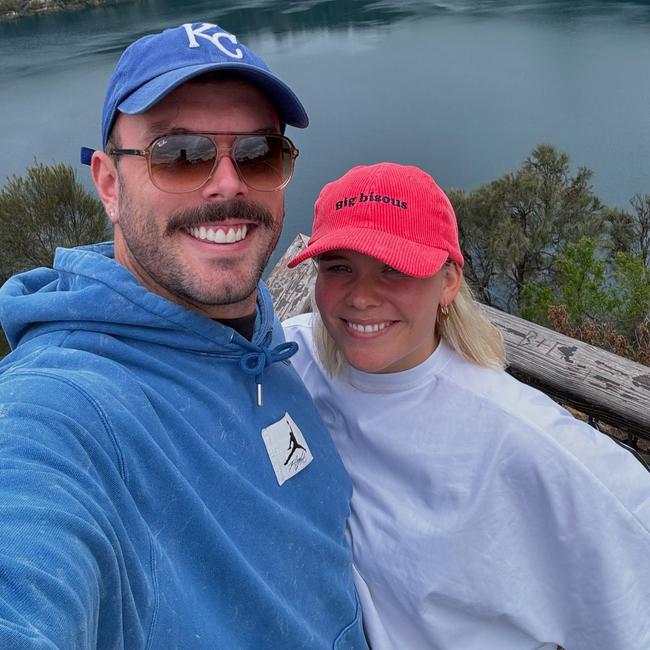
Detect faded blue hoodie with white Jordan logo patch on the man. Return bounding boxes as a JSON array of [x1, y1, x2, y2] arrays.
[[0, 244, 367, 650]]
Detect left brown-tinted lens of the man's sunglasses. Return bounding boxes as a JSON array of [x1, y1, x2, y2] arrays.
[[149, 134, 217, 192]]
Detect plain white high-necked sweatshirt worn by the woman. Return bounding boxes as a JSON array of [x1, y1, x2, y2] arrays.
[[284, 314, 650, 650]]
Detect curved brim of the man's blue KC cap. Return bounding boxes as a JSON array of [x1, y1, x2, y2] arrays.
[[117, 63, 309, 129]]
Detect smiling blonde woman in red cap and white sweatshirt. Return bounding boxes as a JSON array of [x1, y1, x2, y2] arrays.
[[285, 163, 650, 650]]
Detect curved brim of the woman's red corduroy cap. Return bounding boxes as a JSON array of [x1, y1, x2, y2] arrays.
[[287, 228, 449, 278]]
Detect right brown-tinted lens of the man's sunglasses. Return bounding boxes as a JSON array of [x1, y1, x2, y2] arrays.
[[233, 135, 293, 191]]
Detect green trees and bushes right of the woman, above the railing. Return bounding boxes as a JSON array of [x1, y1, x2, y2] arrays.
[[448, 145, 650, 363]]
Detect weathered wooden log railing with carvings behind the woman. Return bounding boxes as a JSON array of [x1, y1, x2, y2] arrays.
[[267, 235, 650, 440]]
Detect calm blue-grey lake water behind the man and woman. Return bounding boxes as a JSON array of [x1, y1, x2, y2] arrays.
[[0, 0, 650, 264]]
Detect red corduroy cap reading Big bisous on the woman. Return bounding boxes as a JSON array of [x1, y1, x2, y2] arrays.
[[289, 163, 464, 277]]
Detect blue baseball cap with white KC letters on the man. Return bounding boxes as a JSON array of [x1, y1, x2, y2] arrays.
[[90, 22, 309, 154]]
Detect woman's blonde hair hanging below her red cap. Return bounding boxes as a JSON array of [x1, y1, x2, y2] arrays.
[[311, 278, 506, 377]]
